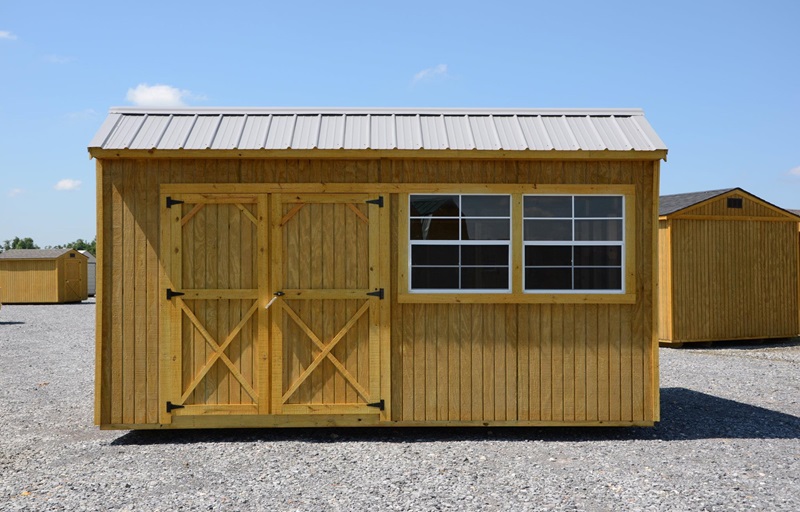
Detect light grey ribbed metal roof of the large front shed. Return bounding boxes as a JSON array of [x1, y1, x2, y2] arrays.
[[89, 108, 667, 152]]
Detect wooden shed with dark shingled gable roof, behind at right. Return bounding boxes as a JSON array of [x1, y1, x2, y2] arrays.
[[659, 188, 800, 345]]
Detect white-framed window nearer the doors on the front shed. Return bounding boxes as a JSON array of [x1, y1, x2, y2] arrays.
[[409, 194, 511, 293]]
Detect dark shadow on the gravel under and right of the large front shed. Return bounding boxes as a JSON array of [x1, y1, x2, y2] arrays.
[[111, 388, 800, 445]]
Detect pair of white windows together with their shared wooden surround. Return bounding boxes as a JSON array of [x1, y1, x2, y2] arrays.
[[397, 183, 636, 304]]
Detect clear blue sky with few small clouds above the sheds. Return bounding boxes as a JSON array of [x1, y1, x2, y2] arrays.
[[0, 0, 800, 247]]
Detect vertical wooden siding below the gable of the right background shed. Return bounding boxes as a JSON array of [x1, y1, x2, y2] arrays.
[[665, 219, 800, 342]]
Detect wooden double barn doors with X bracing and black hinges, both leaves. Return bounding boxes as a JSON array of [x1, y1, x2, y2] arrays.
[[160, 193, 388, 423]]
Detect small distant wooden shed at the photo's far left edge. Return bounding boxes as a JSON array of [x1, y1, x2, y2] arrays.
[[0, 249, 88, 304]]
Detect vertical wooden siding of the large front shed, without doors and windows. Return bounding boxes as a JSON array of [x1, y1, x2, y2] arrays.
[[96, 159, 656, 427]]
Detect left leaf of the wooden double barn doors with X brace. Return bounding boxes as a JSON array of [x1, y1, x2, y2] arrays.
[[160, 194, 268, 423]]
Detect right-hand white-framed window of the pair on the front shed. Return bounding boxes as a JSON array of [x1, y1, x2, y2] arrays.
[[523, 195, 625, 293]]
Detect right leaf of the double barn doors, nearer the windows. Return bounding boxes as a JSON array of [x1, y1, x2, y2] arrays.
[[270, 194, 388, 418]]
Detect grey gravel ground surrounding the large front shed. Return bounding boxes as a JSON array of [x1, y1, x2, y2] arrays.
[[0, 301, 800, 511]]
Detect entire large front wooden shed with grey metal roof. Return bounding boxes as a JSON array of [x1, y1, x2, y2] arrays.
[[89, 108, 667, 429]]
